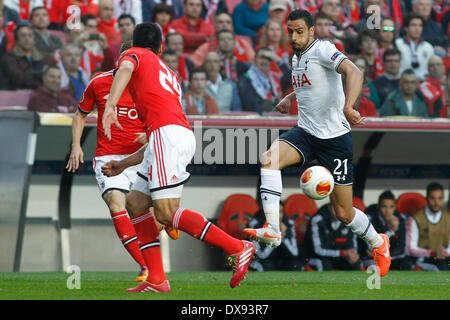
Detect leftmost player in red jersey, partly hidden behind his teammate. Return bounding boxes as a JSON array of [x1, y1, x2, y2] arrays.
[[66, 40, 178, 282]]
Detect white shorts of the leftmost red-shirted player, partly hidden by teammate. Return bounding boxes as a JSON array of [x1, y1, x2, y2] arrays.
[[93, 155, 139, 197]]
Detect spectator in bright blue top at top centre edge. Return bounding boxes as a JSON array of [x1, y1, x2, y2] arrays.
[[233, 0, 269, 43]]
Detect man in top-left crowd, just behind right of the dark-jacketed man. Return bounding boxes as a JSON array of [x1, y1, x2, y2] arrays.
[[30, 7, 63, 56]]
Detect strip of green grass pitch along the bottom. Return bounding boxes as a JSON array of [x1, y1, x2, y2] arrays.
[[0, 271, 450, 301]]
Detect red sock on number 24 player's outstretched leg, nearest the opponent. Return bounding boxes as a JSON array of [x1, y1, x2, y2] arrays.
[[172, 208, 243, 254]]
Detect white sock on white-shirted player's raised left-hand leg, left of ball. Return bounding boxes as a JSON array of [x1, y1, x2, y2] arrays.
[[260, 169, 283, 232]]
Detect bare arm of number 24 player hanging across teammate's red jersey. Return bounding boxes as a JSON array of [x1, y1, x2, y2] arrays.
[[102, 61, 134, 140]]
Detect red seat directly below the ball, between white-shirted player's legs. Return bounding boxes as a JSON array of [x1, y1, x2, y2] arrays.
[[284, 193, 318, 248]]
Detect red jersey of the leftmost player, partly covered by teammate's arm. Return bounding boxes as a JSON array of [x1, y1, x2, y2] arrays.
[[78, 70, 145, 157]]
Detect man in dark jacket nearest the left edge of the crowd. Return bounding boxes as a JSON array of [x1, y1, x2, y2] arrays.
[[1, 25, 49, 90]]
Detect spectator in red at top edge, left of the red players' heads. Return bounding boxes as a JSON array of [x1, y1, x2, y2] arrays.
[[97, 0, 122, 45]]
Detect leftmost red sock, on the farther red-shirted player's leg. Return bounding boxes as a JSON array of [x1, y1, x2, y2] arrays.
[[111, 211, 145, 268]]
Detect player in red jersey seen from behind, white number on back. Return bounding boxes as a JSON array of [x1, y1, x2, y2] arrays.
[[102, 22, 256, 292]]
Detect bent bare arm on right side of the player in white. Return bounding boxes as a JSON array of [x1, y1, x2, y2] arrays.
[[338, 59, 365, 125]]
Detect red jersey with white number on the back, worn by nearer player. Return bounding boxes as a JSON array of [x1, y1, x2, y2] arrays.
[[119, 47, 191, 133]]
